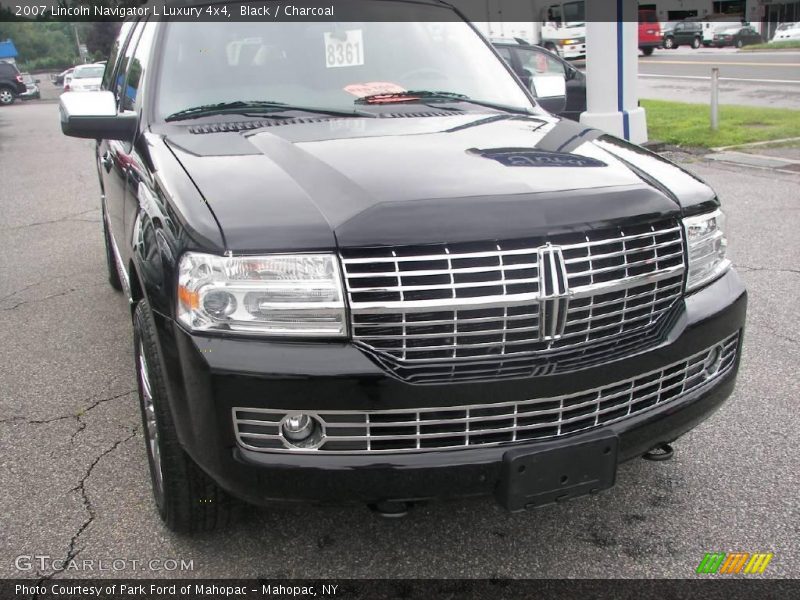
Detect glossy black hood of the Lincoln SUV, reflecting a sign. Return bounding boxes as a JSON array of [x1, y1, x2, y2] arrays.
[[166, 114, 714, 252]]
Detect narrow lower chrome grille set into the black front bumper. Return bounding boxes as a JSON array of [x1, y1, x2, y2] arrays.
[[233, 333, 739, 453]]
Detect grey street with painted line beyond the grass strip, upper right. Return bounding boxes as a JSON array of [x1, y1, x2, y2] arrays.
[[577, 47, 800, 110]]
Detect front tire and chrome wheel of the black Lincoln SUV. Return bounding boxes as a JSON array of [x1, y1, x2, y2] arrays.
[[133, 300, 241, 533]]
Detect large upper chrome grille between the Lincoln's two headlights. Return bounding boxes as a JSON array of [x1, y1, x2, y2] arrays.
[[342, 220, 684, 383]]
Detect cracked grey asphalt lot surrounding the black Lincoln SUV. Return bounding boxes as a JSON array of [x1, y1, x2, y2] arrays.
[[0, 103, 800, 578]]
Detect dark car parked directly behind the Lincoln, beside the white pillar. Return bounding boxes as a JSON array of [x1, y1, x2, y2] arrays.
[[492, 39, 586, 121]]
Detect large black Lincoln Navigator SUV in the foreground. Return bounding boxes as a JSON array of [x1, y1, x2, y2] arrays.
[[60, 0, 746, 531]]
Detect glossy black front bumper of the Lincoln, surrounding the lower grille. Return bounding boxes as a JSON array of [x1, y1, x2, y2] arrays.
[[156, 270, 747, 504]]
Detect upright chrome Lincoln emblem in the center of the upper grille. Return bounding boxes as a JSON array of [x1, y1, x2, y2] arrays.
[[539, 244, 570, 341]]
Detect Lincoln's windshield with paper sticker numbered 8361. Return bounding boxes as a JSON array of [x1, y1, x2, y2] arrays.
[[156, 2, 535, 118]]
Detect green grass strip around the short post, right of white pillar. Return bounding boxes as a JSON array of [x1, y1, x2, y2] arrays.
[[642, 100, 800, 148]]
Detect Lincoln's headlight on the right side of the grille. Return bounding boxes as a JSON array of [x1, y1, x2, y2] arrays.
[[683, 210, 731, 292]]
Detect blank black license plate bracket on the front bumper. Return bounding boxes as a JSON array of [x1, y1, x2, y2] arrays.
[[497, 434, 619, 512]]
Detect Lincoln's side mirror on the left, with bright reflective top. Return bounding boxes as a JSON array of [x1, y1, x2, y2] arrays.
[[59, 91, 139, 141]]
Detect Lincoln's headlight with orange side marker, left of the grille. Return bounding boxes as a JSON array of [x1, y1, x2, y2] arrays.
[[177, 252, 347, 337]]
